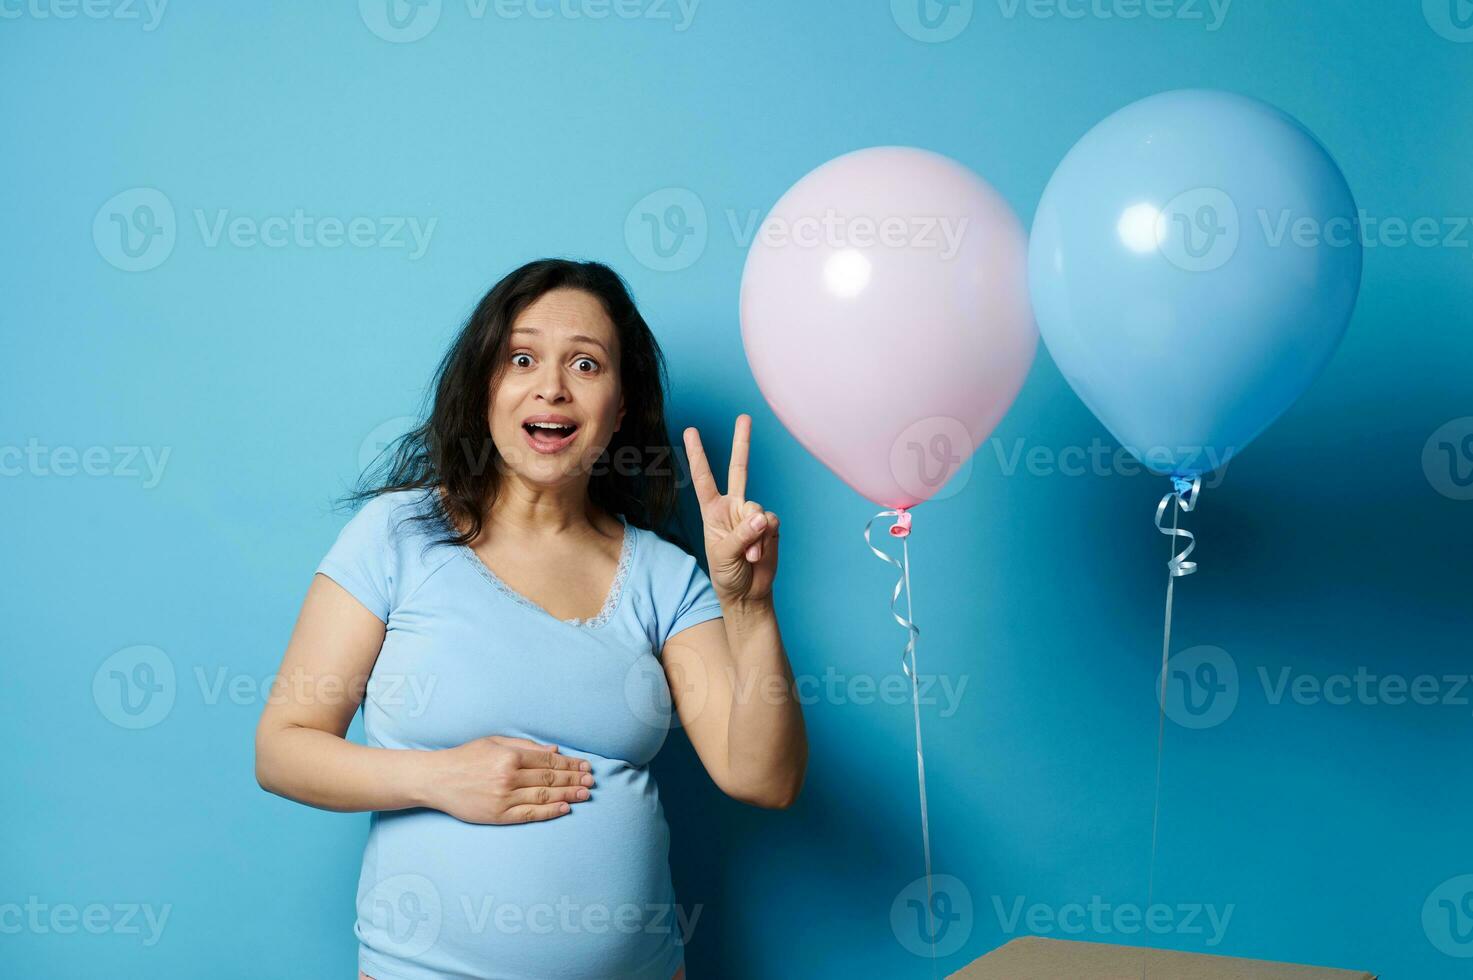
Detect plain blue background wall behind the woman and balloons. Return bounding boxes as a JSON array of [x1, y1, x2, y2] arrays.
[[0, 0, 1473, 980]]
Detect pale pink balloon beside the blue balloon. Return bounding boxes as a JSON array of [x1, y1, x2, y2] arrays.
[[741, 146, 1038, 508]]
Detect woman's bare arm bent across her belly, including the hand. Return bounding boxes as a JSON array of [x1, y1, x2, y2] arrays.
[[256, 575, 592, 824]]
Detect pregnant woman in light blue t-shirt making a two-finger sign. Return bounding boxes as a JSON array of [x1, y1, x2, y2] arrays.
[[256, 259, 807, 980]]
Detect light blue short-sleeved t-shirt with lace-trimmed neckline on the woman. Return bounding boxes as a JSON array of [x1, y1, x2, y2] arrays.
[[318, 491, 722, 980]]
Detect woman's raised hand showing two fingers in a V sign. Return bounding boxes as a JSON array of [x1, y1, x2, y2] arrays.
[[685, 413, 778, 603]]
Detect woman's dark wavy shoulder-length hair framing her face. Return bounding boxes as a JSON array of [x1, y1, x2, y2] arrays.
[[343, 258, 683, 544]]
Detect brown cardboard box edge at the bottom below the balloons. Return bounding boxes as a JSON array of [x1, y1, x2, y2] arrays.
[[949, 936, 1376, 980]]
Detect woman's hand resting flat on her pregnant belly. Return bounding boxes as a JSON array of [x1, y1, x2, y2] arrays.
[[429, 735, 594, 824]]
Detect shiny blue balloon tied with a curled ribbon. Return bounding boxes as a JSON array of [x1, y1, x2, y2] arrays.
[[1028, 90, 1363, 477]]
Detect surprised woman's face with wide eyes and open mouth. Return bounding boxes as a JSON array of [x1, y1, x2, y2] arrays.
[[488, 289, 625, 486]]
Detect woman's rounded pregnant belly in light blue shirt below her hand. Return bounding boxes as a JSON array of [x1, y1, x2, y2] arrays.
[[355, 753, 686, 980]]
